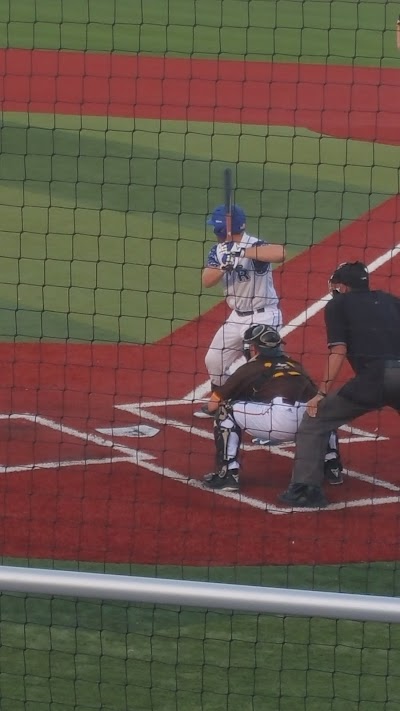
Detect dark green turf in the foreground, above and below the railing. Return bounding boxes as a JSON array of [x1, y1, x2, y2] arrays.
[[0, 559, 400, 711]]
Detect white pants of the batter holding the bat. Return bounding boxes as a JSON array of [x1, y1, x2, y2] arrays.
[[205, 309, 282, 385]]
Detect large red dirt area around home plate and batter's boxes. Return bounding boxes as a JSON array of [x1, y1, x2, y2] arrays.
[[0, 198, 400, 565]]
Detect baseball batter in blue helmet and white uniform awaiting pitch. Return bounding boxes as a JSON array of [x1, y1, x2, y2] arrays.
[[197, 205, 285, 416]]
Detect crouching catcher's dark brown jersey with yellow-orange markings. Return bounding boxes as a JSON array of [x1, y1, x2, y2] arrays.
[[215, 355, 317, 403]]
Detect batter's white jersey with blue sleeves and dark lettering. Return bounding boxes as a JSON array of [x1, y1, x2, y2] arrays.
[[206, 232, 279, 312]]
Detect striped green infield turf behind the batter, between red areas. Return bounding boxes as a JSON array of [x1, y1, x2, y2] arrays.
[[0, 114, 400, 343]]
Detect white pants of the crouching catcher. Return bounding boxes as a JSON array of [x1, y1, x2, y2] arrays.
[[221, 397, 307, 469]]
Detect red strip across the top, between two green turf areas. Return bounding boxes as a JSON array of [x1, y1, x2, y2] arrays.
[[0, 49, 400, 145]]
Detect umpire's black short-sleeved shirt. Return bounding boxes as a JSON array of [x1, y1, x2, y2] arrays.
[[325, 289, 400, 404]]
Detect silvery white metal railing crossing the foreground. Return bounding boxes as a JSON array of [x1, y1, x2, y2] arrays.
[[0, 566, 400, 622]]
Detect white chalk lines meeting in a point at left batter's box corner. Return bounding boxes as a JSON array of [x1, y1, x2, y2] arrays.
[[0, 412, 155, 473]]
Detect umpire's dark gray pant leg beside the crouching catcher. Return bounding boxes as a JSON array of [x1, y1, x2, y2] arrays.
[[292, 393, 375, 486]]
